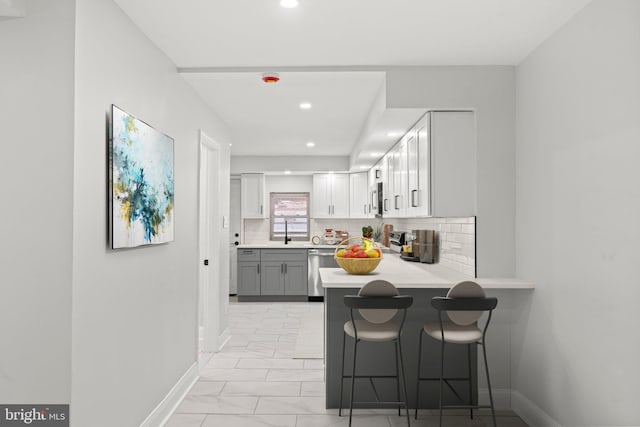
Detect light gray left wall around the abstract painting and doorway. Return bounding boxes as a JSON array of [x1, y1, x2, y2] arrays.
[[71, 0, 230, 427]]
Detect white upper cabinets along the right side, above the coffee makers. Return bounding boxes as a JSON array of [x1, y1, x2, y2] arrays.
[[369, 111, 476, 218]]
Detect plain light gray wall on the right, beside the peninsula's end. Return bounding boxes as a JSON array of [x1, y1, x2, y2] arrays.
[[512, 0, 640, 426]]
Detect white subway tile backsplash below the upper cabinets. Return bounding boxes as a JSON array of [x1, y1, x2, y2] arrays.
[[243, 217, 476, 277]]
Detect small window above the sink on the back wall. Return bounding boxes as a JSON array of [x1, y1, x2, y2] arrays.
[[269, 193, 309, 241]]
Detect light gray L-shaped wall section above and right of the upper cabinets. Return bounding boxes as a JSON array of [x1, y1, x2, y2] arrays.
[[387, 66, 515, 277]]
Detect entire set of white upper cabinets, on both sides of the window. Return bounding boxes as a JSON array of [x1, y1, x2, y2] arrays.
[[241, 111, 476, 218]]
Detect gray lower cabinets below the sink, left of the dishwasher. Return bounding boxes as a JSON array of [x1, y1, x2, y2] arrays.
[[238, 249, 308, 300]]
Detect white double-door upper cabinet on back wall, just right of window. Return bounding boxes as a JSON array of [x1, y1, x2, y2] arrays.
[[312, 173, 349, 218]]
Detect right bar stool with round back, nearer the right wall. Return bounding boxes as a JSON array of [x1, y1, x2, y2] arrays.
[[415, 281, 498, 427]]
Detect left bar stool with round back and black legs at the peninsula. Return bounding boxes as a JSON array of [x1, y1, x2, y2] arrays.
[[338, 280, 413, 426]]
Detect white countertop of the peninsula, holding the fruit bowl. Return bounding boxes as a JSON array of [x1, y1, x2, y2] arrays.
[[320, 254, 534, 289]]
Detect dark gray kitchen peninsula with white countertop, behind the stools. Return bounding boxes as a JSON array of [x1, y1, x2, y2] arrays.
[[320, 254, 534, 408]]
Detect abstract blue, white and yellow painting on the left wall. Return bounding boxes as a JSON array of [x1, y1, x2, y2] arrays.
[[110, 105, 174, 249]]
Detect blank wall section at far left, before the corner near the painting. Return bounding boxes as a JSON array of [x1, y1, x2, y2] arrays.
[[0, 0, 75, 404]]
